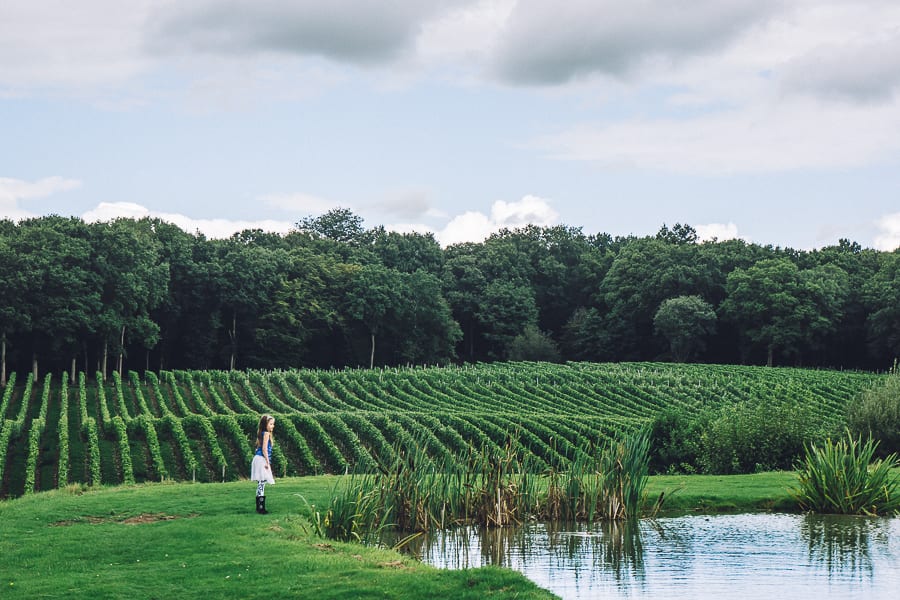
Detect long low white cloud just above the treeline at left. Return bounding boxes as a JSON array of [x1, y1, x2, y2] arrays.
[[82, 202, 293, 238]]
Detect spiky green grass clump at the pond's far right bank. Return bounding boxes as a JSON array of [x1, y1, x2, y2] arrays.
[[791, 431, 900, 516]]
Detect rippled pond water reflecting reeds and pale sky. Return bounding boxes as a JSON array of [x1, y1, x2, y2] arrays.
[[400, 514, 900, 600]]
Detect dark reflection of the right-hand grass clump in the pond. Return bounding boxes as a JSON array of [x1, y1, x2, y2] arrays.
[[800, 514, 888, 579]]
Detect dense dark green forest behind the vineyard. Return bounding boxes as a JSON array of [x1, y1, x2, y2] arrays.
[[0, 209, 900, 383]]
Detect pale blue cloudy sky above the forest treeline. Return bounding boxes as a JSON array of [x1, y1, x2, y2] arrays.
[[0, 0, 900, 250]]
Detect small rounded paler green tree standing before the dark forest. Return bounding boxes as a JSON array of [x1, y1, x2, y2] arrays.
[[653, 296, 716, 362]]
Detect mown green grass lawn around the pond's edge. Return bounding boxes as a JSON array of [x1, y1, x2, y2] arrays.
[[0, 472, 808, 599]]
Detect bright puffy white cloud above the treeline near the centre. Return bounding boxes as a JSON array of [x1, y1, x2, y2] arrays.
[[435, 196, 559, 246]]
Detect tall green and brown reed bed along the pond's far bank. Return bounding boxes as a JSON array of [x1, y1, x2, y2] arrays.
[[308, 432, 649, 543]]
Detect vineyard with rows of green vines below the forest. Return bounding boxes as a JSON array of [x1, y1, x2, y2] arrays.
[[0, 363, 879, 498]]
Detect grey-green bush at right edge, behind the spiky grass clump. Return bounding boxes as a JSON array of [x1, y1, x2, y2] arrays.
[[847, 366, 900, 458]]
